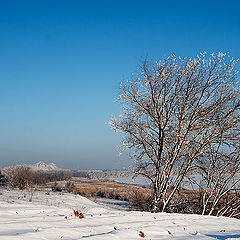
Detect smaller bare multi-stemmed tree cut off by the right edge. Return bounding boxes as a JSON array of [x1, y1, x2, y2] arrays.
[[189, 88, 240, 216]]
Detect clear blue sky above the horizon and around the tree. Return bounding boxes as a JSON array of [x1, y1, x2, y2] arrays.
[[0, 0, 240, 169]]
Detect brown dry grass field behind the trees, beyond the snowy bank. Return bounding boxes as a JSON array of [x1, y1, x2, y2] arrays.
[[38, 177, 239, 218]]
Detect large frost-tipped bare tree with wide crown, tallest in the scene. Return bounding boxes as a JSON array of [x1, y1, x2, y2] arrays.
[[110, 53, 239, 211]]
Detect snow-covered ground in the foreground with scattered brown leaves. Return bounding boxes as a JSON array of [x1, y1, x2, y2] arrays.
[[0, 189, 240, 240]]
